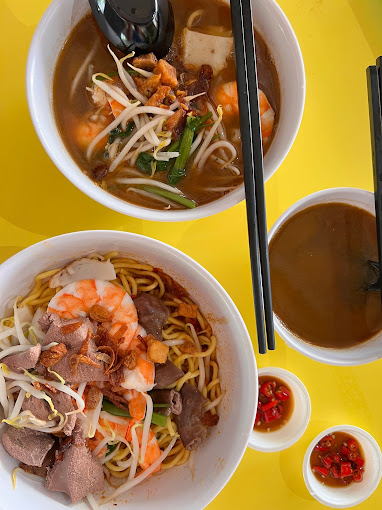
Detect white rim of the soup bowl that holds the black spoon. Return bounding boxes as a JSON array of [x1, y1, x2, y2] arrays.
[[25, 0, 306, 222]]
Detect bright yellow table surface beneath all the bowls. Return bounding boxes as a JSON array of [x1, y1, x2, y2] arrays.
[[0, 0, 382, 510]]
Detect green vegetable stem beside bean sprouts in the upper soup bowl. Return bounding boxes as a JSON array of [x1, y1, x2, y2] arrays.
[[168, 112, 212, 185]]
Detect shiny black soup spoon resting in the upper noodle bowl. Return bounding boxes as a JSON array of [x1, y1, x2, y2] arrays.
[[89, 0, 174, 58]]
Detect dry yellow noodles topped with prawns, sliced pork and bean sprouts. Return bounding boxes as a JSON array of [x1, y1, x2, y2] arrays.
[[0, 252, 223, 508]]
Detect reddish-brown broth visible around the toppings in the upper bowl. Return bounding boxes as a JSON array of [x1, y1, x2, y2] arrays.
[[53, 0, 280, 209]]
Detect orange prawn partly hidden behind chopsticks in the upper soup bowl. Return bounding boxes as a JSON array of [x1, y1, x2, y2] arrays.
[[215, 81, 275, 144]]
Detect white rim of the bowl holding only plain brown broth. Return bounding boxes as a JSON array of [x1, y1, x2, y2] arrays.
[[268, 186, 382, 366]]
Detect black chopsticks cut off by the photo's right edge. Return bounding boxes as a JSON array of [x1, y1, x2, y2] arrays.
[[366, 57, 382, 290]]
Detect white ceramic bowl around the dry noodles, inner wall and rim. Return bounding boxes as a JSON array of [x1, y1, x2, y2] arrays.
[[0, 231, 258, 510]]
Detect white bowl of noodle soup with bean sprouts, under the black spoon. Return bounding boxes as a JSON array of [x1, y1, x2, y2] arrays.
[[27, 0, 305, 221]]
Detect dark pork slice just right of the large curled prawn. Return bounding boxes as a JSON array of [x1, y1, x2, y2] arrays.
[[134, 292, 170, 340]]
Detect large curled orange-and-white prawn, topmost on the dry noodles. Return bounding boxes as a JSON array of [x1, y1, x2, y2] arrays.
[[48, 280, 138, 352]]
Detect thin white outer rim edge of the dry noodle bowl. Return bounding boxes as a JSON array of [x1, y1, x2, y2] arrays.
[[0, 230, 257, 508]]
